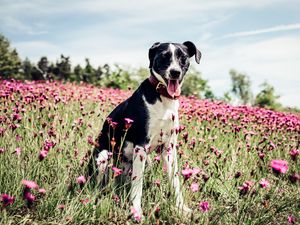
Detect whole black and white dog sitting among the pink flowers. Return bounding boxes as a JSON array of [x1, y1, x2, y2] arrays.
[[89, 41, 201, 216]]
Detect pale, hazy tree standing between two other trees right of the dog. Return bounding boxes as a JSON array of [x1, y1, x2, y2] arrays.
[[229, 70, 252, 105]]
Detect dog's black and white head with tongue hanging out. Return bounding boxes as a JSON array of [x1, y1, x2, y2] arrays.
[[149, 41, 201, 97]]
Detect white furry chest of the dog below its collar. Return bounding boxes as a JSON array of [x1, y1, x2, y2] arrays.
[[146, 97, 179, 149]]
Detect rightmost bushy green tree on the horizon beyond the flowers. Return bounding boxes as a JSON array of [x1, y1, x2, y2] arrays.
[[254, 82, 281, 109]]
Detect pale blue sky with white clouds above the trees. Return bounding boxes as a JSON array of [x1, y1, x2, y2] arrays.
[[0, 0, 300, 107]]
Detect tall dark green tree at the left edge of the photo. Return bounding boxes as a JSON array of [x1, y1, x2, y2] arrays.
[[0, 34, 21, 78]]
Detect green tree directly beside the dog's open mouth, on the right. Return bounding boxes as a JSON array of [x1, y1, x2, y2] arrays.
[[181, 67, 215, 99]]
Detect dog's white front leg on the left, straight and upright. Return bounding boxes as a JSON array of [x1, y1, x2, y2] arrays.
[[130, 146, 147, 218]]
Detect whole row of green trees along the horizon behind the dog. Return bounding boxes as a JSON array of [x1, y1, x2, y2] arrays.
[[0, 34, 299, 112]]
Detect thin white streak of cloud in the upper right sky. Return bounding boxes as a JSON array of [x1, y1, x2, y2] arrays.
[[221, 23, 300, 39]]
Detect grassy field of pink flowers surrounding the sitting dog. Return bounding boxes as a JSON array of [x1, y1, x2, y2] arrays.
[[0, 80, 300, 224]]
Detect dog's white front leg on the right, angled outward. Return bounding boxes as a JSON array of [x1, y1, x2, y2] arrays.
[[163, 134, 192, 213]]
